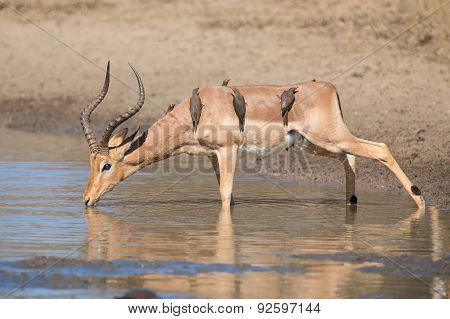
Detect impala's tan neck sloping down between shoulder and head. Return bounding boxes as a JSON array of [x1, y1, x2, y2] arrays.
[[125, 114, 192, 177]]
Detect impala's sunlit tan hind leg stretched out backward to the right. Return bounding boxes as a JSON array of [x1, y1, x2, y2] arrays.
[[339, 137, 425, 208]]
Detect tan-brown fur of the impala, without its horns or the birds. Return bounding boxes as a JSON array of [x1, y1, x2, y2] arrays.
[[85, 81, 425, 207]]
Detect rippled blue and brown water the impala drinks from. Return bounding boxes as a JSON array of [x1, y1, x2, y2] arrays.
[[0, 131, 450, 298]]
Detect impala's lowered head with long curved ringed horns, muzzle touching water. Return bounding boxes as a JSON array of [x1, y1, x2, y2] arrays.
[[81, 62, 145, 206]]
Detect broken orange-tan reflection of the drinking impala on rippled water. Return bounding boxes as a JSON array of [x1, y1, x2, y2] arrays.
[[82, 208, 446, 298]]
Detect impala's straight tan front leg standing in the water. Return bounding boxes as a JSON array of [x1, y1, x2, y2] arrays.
[[217, 145, 237, 208]]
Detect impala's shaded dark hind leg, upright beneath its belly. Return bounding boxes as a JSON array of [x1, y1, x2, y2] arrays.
[[304, 142, 358, 205]]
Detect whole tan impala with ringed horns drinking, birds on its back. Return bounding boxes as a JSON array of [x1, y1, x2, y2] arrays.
[[81, 63, 425, 208]]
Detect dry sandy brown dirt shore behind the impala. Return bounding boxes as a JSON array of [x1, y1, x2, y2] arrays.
[[0, 0, 450, 209]]
